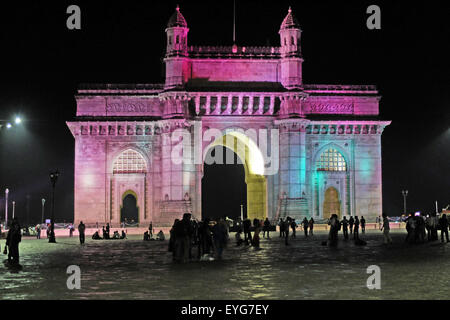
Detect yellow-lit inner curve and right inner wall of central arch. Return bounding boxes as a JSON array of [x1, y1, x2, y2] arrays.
[[203, 131, 267, 220]]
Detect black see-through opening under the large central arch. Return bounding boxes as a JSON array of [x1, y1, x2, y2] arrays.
[[202, 146, 247, 220]]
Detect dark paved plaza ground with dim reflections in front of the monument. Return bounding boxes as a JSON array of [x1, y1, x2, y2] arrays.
[[0, 231, 450, 300]]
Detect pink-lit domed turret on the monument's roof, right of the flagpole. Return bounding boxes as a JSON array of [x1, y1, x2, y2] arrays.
[[278, 7, 303, 89]]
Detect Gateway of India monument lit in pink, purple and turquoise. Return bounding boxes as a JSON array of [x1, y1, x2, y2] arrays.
[[67, 7, 390, 226]]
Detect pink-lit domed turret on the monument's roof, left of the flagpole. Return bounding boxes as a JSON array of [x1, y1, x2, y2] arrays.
[[164, 6, 189, 89]]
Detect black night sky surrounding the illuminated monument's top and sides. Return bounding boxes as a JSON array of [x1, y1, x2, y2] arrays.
[[0, 0, 450, 225]]
